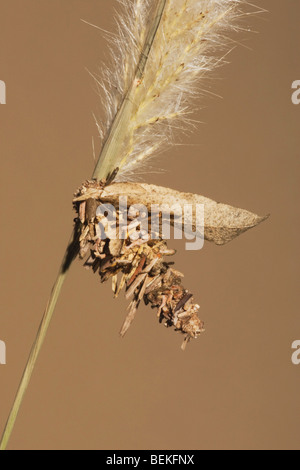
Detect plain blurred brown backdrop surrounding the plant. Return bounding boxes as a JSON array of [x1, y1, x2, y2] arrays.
[[0, 0, 300, 450]]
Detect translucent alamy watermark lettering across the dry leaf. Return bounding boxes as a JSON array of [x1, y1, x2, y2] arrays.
[[96, 196, 204, 251]]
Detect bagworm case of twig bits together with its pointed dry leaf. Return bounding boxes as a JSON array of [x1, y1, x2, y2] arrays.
[[73, 181, 265, 349]]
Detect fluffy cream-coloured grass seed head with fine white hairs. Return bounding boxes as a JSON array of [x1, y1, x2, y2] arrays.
[[91, 0, 253, 180]]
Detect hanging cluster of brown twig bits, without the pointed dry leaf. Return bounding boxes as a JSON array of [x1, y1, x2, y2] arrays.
[[74, 181, 204, 348]]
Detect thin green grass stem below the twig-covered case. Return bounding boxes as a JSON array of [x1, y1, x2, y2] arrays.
[[0, 229, 78, 450]]
